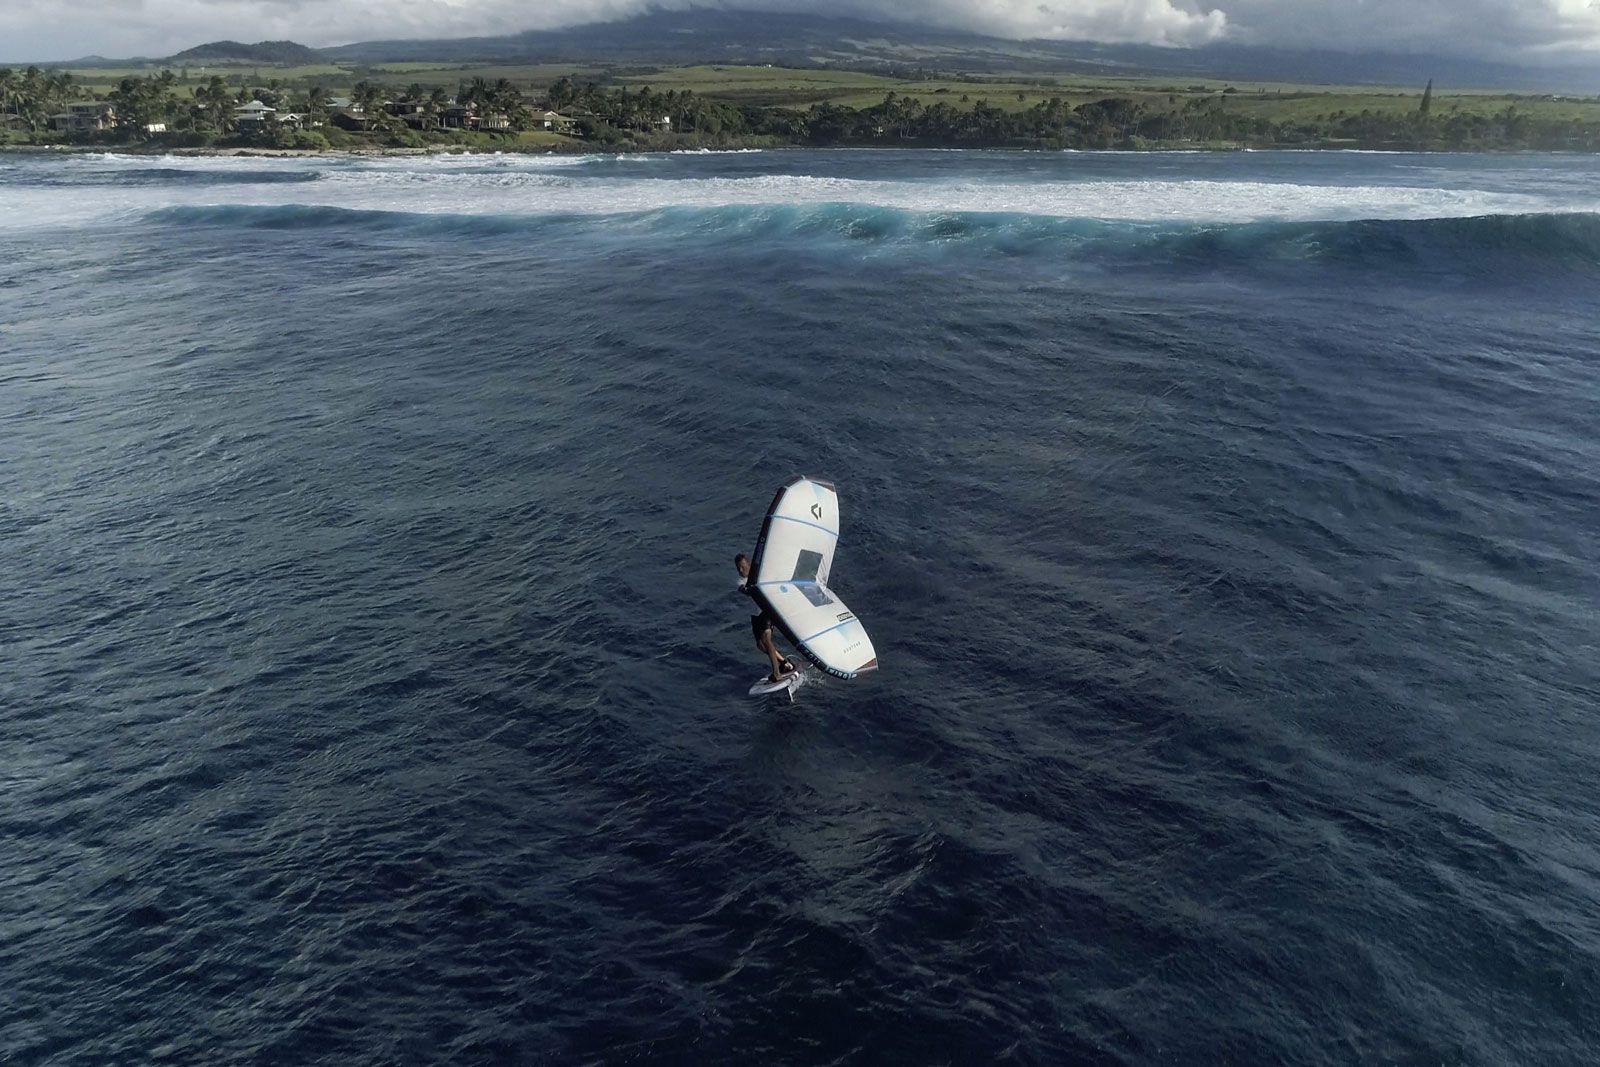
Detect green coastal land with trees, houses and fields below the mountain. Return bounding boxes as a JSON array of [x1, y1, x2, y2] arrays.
[[0, 60, 1600, 152]]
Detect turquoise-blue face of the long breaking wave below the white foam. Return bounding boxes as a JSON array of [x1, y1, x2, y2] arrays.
[[149, 203, 1600, 277]]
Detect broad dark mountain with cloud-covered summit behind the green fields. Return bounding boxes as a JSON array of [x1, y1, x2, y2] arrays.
[[323, 8, 1600, 93]]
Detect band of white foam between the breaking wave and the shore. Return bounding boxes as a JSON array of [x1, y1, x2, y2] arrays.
[[0, 154, 1600, 229]]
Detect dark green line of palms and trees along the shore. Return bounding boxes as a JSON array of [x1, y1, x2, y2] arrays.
[[0, 67, 1600, 150]]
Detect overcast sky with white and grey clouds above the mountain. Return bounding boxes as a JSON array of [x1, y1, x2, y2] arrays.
[[0, 0, 1600, 64]]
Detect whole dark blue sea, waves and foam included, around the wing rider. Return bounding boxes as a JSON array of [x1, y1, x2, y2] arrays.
[[0, 152, 1600, 1065]]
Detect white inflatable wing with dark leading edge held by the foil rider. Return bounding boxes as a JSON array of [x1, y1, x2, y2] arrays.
[[749, 477, 878, 678]]
